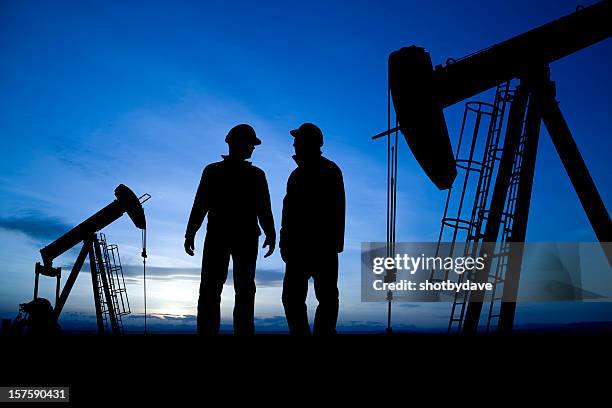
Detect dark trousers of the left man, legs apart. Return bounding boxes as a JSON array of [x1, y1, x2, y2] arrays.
[[198, 231, 259, 335]]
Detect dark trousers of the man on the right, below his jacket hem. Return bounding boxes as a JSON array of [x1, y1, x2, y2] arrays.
[[283, 251, 338, 335]]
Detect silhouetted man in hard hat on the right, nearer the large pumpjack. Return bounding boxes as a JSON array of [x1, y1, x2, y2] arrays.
[[279, 123, 345, 335]]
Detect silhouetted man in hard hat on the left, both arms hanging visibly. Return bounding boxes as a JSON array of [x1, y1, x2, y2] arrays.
[[185, 124, 276, 334]]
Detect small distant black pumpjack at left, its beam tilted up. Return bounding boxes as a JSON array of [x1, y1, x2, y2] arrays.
[[20, 184, 151, 334]]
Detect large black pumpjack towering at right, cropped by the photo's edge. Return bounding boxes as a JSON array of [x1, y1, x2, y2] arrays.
[[373, 0, 612, 334]]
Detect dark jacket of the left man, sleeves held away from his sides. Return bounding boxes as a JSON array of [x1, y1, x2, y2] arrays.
[[185, 156, 276, 239]]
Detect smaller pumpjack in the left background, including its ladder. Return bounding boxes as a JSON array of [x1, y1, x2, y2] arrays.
[[13, 184, 151, 335]]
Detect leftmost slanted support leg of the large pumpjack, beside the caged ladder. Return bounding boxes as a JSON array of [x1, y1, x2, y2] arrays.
[[461, 83, 528, 335]]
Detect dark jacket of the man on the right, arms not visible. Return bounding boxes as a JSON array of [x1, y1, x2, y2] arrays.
[[279, 156, 345, 253]]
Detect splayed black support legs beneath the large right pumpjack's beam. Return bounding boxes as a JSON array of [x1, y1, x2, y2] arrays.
[[462, 67, 612, 335]]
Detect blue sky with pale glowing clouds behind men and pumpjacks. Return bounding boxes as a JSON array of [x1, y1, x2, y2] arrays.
[[0, 0, 612, 329]]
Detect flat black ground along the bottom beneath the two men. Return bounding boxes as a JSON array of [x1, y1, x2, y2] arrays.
[[0, 333, 612, 407]]
